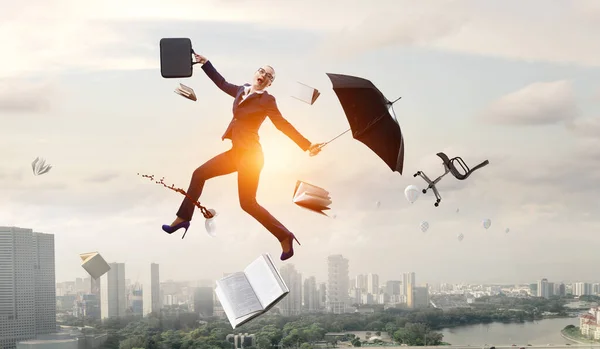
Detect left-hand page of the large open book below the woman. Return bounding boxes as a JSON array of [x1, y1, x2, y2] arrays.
[[217, 272, 263, 319]]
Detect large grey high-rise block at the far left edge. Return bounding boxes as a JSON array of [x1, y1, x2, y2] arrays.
[[0, 227, 56, 349]]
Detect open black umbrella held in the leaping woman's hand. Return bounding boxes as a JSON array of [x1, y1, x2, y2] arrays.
[[323, 73, 404, 174]]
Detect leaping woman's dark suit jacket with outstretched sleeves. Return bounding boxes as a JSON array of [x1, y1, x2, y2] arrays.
[[202, 61, 311, 151]]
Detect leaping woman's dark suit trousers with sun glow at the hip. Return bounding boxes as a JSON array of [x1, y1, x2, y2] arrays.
[[177, 146, 291, 241]]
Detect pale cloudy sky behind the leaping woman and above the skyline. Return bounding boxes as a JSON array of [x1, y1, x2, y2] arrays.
[[0, 0, 600, 283]]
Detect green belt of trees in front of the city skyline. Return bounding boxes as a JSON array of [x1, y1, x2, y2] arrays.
[[63, 296, 570, 349]]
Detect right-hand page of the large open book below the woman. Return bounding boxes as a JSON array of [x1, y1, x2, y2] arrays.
[[244, 255, 287, 308]]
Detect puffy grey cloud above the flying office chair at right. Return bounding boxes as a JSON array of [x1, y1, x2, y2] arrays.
[[482, 80, 579, 125]]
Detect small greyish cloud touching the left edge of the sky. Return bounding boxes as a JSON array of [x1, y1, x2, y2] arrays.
[[0, 79, 56, 113]]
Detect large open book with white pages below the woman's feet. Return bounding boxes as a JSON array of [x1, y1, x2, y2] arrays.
[[215, 253, 290, 329]]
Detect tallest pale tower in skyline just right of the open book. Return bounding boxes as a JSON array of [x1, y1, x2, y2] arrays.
[[327, 254, 350, 314]]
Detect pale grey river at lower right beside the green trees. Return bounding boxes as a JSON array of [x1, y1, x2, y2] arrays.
[[440, 318, 579, 346]]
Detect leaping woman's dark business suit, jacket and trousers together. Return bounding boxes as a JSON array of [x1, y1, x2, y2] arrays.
[[177, 61, 311, 241]]
